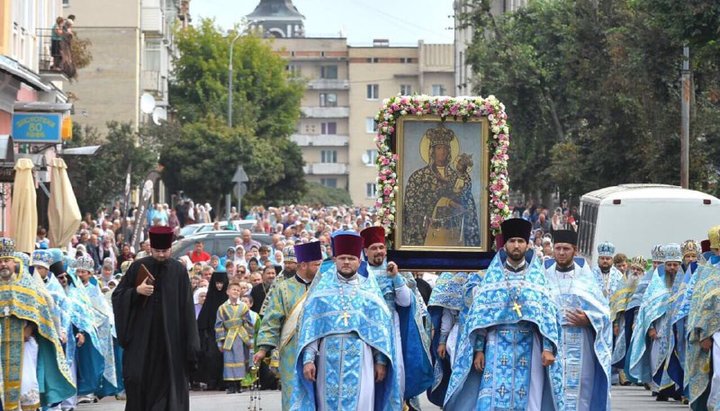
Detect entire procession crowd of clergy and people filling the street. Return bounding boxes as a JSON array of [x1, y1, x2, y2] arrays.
[[0, 203, 720, 410]]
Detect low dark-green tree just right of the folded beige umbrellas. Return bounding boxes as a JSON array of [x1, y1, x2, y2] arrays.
[[63, 122, 157, 213]]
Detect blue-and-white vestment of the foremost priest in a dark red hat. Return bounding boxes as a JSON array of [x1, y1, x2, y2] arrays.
[[290, 270, 402, 411]]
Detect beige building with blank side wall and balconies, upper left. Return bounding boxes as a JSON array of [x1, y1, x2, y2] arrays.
[[64, 0, 189, 130]]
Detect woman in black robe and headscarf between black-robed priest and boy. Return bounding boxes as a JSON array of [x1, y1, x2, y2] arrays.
[[195, 272, 228, 390]]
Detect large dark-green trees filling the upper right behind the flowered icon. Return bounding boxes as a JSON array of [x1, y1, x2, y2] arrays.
[[463, 0, 720, 203]]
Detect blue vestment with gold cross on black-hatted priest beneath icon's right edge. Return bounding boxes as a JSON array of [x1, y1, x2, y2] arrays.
[[445, 251, 564, 411]]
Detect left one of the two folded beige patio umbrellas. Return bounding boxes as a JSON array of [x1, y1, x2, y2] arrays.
[[10, 158, 37, 253]]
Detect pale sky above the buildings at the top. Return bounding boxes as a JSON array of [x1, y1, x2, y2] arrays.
[[190, 0, 453, 46]]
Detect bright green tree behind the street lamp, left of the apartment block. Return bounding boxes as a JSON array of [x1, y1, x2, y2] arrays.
[[162, 19, 306, 211]]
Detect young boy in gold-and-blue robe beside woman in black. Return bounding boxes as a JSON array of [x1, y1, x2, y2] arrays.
[[215, 281, 256, 394]]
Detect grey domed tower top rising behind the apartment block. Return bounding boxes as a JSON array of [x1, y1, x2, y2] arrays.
[[246, 0, 305, 38]]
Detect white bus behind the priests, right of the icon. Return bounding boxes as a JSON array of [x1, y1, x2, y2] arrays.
[[578, 184, 720, 264]]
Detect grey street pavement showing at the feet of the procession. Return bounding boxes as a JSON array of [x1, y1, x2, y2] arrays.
[[77, 387, 687, 411]]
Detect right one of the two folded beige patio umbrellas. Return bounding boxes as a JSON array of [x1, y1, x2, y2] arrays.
[[48, 158, 81, 247]]
